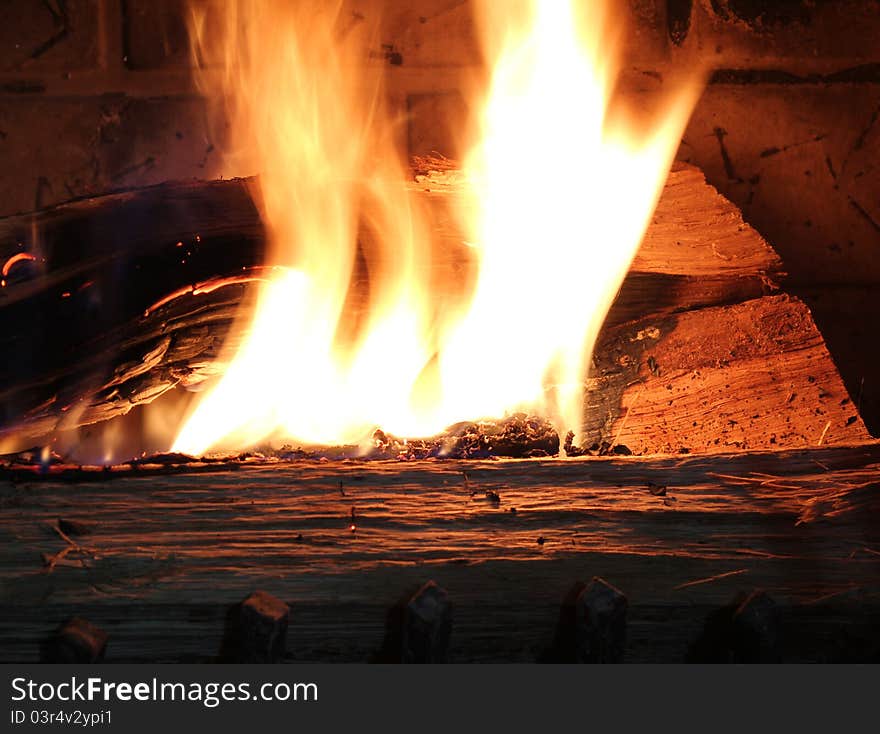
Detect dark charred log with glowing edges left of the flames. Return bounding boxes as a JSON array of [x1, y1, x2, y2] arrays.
[[0, 180, 265, 448]]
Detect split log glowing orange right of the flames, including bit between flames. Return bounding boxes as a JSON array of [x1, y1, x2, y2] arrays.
[[417, 161, 870, 454]]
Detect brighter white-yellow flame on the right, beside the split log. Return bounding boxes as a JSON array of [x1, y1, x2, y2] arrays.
[[444, 0, 697, 432]]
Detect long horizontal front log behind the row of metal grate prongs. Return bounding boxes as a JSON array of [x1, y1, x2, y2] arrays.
[[0, 444, 880, 662]]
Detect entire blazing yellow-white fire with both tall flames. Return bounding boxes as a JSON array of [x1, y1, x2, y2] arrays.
[[173, 0, 696, 453]]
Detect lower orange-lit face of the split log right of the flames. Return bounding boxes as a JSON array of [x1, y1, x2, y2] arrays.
[[585, 295, 869, 453]]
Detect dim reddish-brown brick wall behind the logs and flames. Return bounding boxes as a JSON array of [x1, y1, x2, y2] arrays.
[[0, 0, 880, 433]]
